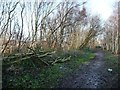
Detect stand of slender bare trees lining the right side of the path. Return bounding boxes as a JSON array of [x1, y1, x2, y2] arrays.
[[104, 3, 119, 54]]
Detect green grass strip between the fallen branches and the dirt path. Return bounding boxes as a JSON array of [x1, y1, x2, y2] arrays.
[[3, 50, 95, 88]]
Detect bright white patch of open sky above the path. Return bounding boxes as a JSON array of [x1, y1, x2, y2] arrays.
[[87, 0, 116, 19]]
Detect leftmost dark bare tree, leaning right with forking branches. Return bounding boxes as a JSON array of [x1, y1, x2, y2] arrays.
[[0, 2, 19, 53]]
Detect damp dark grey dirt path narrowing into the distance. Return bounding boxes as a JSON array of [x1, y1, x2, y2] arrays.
[[58, 51, 116, 88]]
